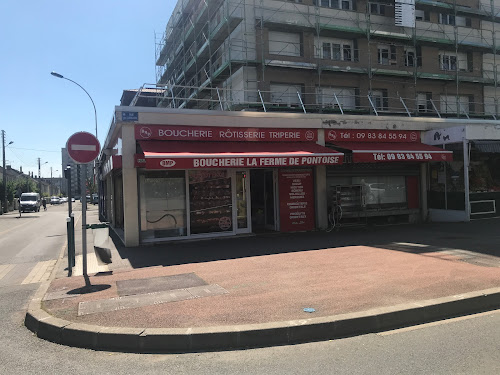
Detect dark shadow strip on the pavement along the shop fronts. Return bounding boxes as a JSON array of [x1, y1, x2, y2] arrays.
[[110, 219, 500, 268]]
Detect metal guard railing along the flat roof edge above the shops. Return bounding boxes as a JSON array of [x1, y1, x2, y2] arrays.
[[128, 83, 500, 119]]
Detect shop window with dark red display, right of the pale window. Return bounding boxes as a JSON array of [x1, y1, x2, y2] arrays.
[[189, 170, 233, 234]]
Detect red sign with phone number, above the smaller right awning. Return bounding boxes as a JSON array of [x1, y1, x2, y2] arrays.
[[325, 129, 420, 143]]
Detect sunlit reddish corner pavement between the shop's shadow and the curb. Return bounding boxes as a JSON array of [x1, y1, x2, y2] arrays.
[[42, 246, 500, 328]]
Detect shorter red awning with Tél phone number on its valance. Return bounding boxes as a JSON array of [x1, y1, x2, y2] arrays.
[[330, 142, 453, 163]]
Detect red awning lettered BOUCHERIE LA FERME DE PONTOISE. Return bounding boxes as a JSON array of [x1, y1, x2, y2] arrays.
[[136, 141, 344, 169]]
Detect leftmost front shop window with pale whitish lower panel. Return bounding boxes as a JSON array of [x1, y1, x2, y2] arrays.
[[140, 171, 187, 239]]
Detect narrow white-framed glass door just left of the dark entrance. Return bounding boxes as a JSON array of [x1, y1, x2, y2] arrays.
[[233, 170, 252, 233]]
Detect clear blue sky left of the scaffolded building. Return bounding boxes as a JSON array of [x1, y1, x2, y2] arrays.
[[0, 0, 176, 181]]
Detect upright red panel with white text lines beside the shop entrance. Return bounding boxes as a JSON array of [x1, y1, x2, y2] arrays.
[[278, 169, 315, 232]]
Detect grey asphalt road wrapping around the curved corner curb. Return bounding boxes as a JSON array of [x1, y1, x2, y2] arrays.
[[0, 209, 500, 375]]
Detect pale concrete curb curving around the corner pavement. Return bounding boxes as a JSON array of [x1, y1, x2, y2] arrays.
[[25, 288, 500, 353]]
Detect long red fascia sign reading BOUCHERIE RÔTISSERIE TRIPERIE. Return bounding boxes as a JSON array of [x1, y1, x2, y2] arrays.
[[135, 124, 318, 142]]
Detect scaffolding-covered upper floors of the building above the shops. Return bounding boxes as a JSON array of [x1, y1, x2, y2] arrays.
[[146, 0, 500, 119]]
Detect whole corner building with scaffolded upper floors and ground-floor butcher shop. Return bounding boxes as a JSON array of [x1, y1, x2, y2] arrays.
[[99, 0, 500, 246]]
